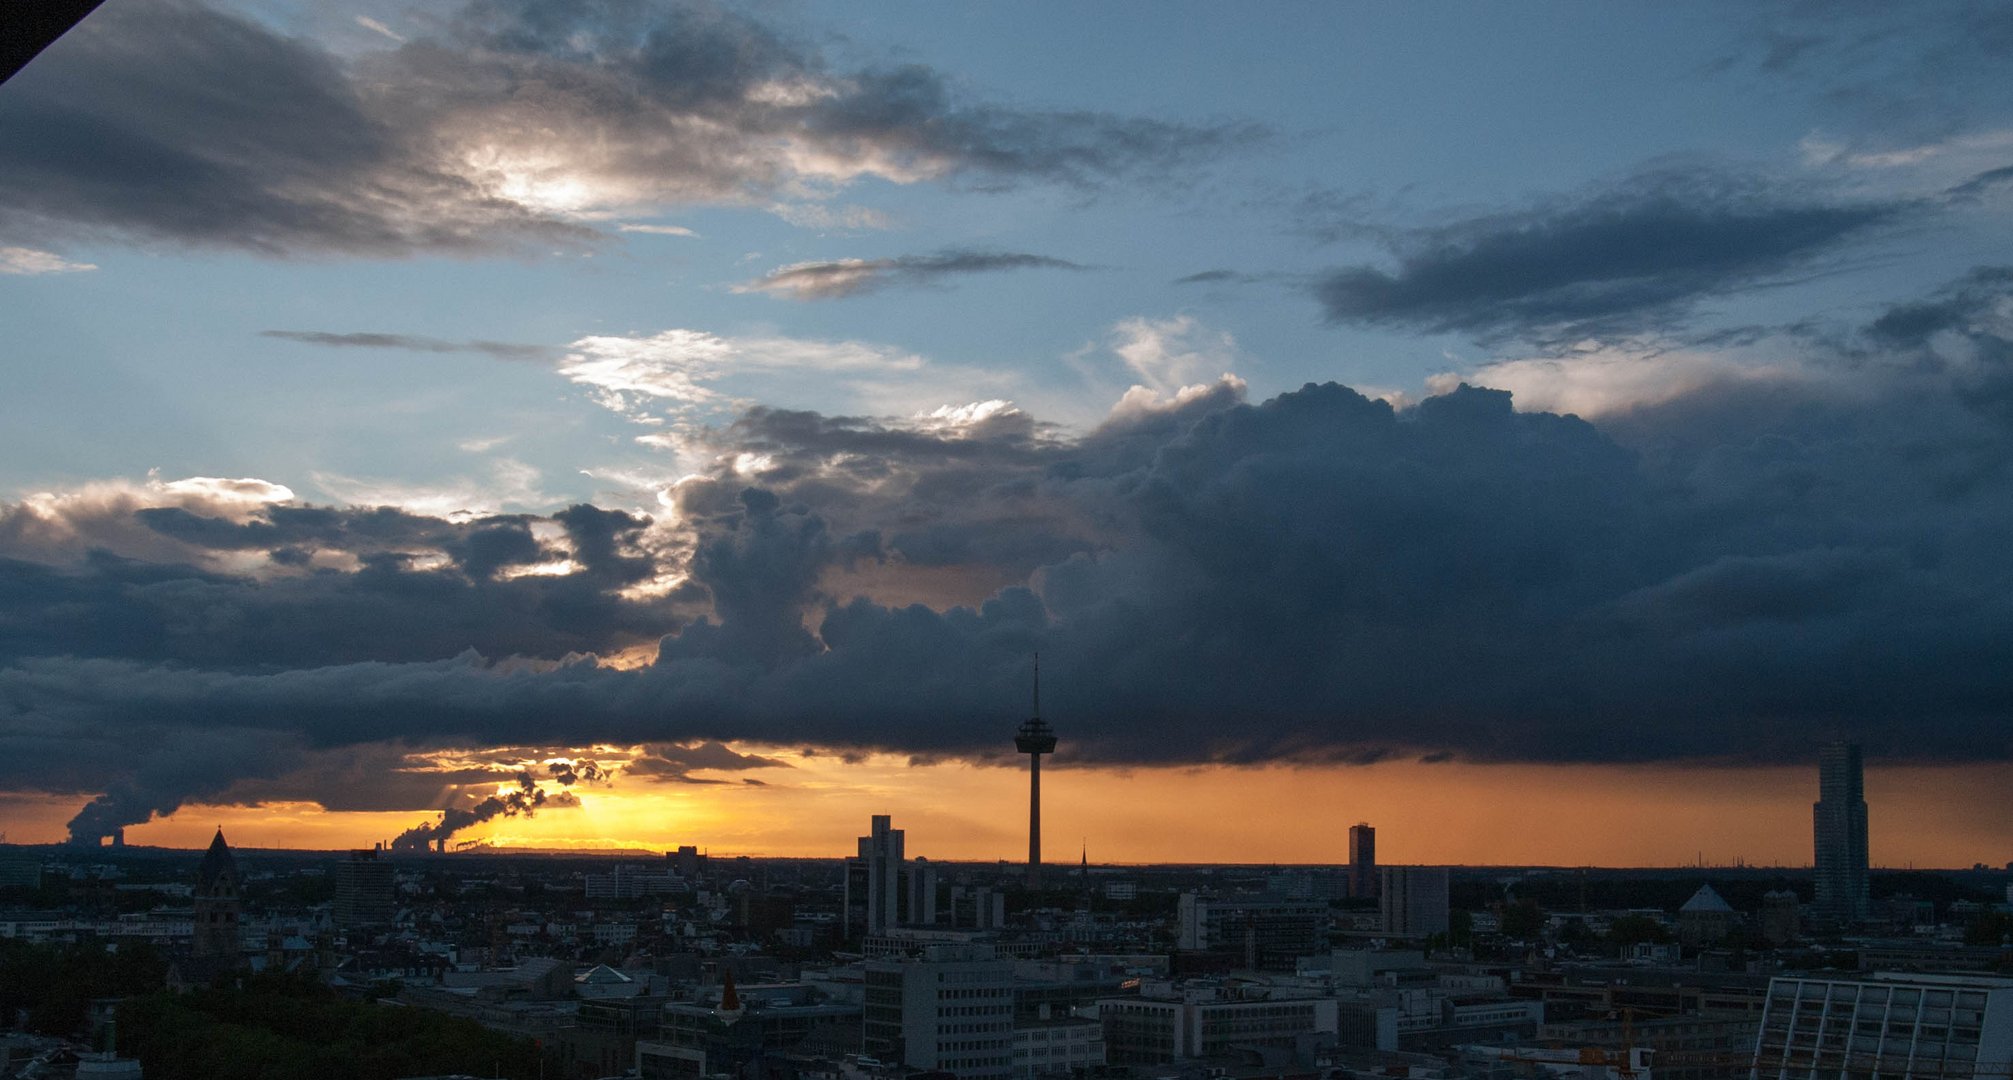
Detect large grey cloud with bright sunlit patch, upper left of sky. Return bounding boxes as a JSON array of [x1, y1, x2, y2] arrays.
[[0, 0, 1260, 255]]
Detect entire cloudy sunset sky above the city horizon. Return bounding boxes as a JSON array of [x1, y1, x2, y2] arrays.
[[0, 0, 2013, 865]]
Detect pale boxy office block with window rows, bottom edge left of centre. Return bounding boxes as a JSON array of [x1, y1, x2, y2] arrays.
[[860, 945, 1015, 1080]]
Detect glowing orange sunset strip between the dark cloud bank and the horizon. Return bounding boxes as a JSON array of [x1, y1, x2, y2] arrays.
[[10, 746, 2013, 867]]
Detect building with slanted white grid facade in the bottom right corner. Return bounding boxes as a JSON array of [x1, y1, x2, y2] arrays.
[[1749, 973, 2013, 1080]]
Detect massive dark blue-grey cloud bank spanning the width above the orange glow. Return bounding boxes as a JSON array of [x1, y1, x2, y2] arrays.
[[0, 283, 2013, 837]]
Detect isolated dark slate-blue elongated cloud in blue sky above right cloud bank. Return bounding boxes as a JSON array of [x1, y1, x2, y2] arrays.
[[1314, 169, 1912, 340]]
